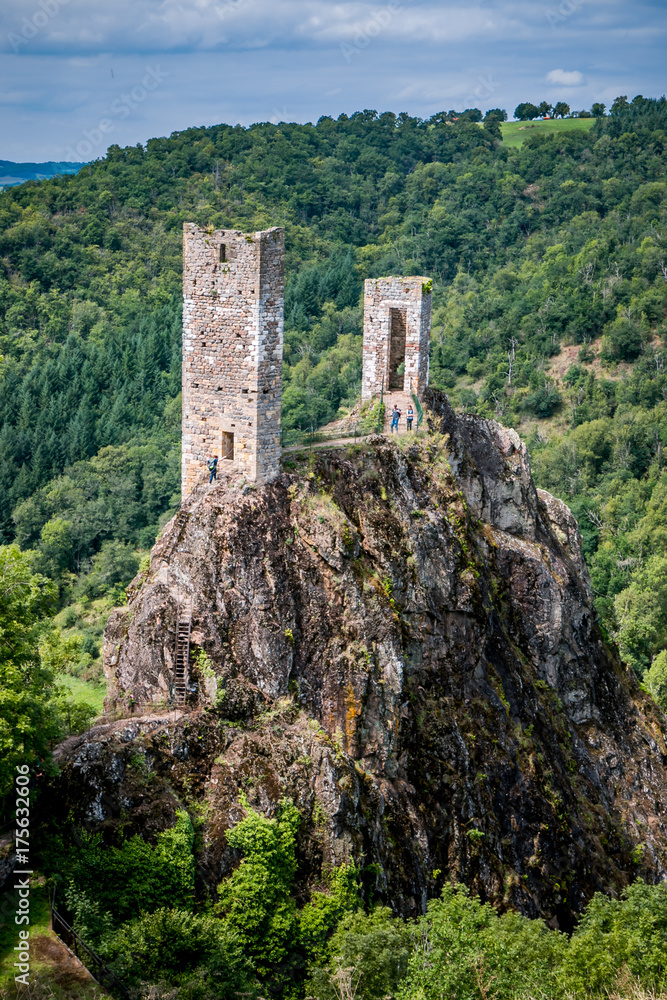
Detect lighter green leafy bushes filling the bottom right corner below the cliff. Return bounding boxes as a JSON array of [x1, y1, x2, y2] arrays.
[[307, 880, 667, 1000]]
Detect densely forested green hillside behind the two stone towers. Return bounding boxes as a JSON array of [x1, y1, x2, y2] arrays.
[[0, 98, 667, 696]]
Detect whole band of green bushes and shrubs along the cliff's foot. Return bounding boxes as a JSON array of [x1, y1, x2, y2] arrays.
[[57, 799, 667, 1000]]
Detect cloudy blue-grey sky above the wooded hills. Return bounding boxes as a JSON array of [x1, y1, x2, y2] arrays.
[[0, 0, 667, 162]]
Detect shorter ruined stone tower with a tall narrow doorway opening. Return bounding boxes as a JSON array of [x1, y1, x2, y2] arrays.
[[361, 278, 431, 399]]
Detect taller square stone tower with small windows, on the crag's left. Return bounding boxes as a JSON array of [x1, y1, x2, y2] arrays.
[[181, 222, 285, 498]]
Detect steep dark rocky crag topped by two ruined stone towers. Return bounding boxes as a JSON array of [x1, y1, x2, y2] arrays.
[[51, 391, 667, 927]]
